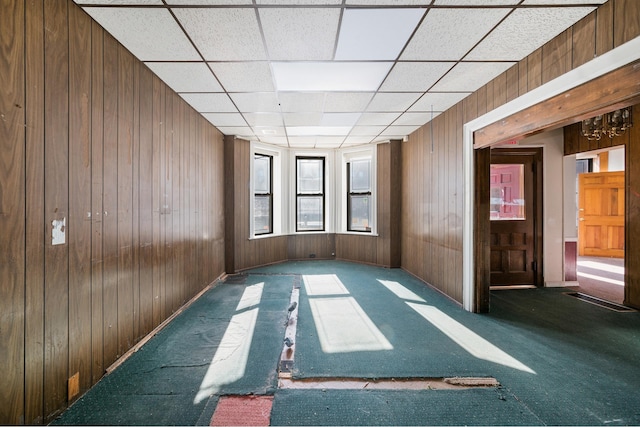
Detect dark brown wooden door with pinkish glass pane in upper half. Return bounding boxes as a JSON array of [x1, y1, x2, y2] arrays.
[[490, 150, 539, 286]]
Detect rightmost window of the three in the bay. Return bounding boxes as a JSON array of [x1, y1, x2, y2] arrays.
[[347, 159, 373, 233]]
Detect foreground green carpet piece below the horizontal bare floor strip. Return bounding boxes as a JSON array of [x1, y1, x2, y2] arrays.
[[271, 388, 542, 426]]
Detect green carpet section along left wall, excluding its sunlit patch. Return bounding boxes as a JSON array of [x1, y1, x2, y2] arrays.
[[53, 276, 293, 425]]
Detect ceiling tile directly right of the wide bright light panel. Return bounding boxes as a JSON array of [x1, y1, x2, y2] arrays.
[[380, 62, 455, 92]]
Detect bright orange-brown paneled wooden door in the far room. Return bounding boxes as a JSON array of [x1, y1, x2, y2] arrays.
[[578, 171, 624, 258]]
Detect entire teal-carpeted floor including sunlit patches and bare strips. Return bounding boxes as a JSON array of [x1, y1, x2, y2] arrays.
[[54, 261, 640, 425]]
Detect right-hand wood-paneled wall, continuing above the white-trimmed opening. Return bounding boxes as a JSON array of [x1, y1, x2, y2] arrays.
[[402, 0, 640, 310]]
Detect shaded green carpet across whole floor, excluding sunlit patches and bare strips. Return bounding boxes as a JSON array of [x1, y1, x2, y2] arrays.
[[54, 261, 640, 426]]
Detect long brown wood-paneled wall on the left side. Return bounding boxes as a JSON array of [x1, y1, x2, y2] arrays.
[[0, 0, 224, 424]]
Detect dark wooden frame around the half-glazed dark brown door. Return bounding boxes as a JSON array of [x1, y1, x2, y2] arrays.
[[490, 146, 544, 287]]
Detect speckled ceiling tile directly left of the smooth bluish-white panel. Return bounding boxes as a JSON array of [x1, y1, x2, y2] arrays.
[[260, 8, 340, 61]]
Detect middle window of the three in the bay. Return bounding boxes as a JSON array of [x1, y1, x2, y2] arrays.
[[296, 157, 325, 231]]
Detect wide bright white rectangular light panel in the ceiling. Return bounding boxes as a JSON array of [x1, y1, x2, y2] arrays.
[[271, 62, 393, 91]]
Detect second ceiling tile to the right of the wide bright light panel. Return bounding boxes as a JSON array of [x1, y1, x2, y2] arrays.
[[432, 62, 514, 92]]
